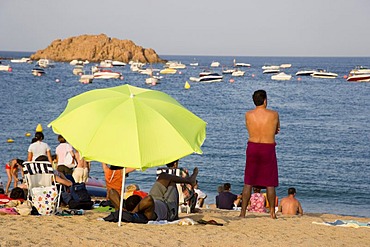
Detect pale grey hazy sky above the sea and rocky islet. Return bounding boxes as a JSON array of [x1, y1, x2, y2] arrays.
[[0, 0, 370, 57]]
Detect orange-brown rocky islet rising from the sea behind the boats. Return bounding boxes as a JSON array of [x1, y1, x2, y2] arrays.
[[30, 34, 165, 63]]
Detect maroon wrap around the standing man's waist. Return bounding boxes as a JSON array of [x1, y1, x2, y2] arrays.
[[244, 142, 279, 187]]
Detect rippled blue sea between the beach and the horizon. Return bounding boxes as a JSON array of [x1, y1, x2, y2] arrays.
[[0, 52, 370, 217]]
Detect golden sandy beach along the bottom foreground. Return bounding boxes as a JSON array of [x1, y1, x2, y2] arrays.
[[0, 206, 370, 247]]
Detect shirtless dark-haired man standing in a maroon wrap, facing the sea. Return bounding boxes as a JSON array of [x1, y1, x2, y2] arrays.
[[240, 90, 280, 219]]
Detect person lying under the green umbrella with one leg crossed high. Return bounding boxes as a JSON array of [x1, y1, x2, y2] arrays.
[[131, 167, 198, 221]]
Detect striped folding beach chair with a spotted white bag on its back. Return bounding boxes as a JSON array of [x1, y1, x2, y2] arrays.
[[23, 161, 61, 215]]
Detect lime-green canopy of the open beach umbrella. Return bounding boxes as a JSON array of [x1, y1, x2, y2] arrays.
[[48, 84, 206, 169]]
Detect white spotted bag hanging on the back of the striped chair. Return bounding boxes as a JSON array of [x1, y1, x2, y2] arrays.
[[32, 185, 58, 215]]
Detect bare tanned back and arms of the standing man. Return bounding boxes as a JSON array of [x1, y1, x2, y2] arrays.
[[245, 103, 280, 143]]
